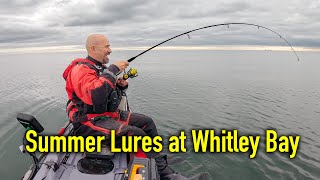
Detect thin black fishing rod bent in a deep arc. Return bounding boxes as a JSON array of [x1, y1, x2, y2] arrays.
[[128, 23, 300, 62]]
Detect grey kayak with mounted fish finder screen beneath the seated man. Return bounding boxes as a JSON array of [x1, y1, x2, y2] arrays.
[[17, 94, 160, 180]]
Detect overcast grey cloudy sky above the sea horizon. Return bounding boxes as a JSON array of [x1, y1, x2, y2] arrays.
[[0, 0, 320, 53]]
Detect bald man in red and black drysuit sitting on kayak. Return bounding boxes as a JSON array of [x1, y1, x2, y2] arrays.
[[63, 34, 184, 179]]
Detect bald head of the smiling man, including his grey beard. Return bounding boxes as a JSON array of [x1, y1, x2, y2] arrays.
[[86, 34, 112, 64]]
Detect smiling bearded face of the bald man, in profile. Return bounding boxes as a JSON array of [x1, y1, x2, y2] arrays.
[[95, 38, 112, 64]]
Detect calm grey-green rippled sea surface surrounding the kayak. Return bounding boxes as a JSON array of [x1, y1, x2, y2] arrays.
[[0, 51, 320, 180]]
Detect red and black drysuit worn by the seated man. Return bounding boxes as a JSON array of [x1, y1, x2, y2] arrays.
[[63, 56, 158, 152]]
